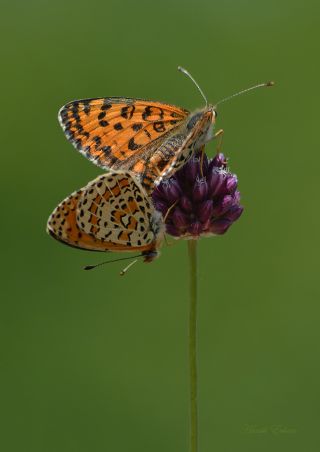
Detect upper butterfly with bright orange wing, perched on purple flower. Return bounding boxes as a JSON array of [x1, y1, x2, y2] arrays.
[[58, 68, 217, 192]]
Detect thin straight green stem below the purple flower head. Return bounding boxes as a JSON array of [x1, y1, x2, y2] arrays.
[[188, 240, 198, 452]]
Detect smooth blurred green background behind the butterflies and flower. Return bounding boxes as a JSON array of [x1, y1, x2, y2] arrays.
[[0, 0, 320, 452]]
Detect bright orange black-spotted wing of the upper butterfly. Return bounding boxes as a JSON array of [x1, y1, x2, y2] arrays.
[[58, 97, 189, 174]]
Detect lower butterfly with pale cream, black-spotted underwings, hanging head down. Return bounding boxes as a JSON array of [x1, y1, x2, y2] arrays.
[[47, 171, 164, 262]]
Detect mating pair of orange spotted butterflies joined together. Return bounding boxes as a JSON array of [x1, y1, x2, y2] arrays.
[[47, 70, 216, 262]]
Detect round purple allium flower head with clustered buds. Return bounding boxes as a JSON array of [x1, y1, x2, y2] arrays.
[[152, 153, 243, 239]]
